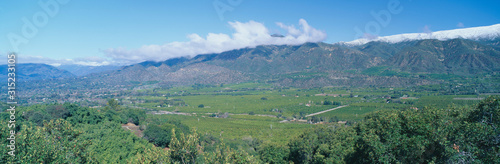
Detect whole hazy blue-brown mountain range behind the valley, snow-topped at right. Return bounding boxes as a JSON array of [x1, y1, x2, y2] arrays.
[[1, 24, 500, 87]]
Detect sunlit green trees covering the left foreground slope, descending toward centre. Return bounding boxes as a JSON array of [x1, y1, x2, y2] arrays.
[[0, 99, 259, 163]]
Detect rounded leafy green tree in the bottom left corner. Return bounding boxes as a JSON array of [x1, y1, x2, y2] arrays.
[[1, 119, 91, 163]]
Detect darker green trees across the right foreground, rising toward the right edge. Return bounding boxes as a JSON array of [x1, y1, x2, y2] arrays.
[[284, 97, 500, 163]]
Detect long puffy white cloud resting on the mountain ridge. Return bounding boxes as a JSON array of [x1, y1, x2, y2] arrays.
[[103, 19, 326, 64]]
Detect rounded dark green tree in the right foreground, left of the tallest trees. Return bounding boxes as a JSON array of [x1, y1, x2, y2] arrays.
[[355, 111, 435, 163]]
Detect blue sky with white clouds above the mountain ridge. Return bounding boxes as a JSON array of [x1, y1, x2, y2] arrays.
[[0, 0, 500, 66]]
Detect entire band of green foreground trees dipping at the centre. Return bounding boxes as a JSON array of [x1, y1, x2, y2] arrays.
[[0, 97, 500, 163]]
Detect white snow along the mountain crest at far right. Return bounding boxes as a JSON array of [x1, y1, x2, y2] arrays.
[[339, 24, 500, 46]]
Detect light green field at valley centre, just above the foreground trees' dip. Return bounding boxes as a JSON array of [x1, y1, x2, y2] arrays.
[[153, 115, 314, 144]]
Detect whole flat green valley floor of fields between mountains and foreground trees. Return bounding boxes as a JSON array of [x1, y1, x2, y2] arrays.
[[114, 83, 492, 145]]
